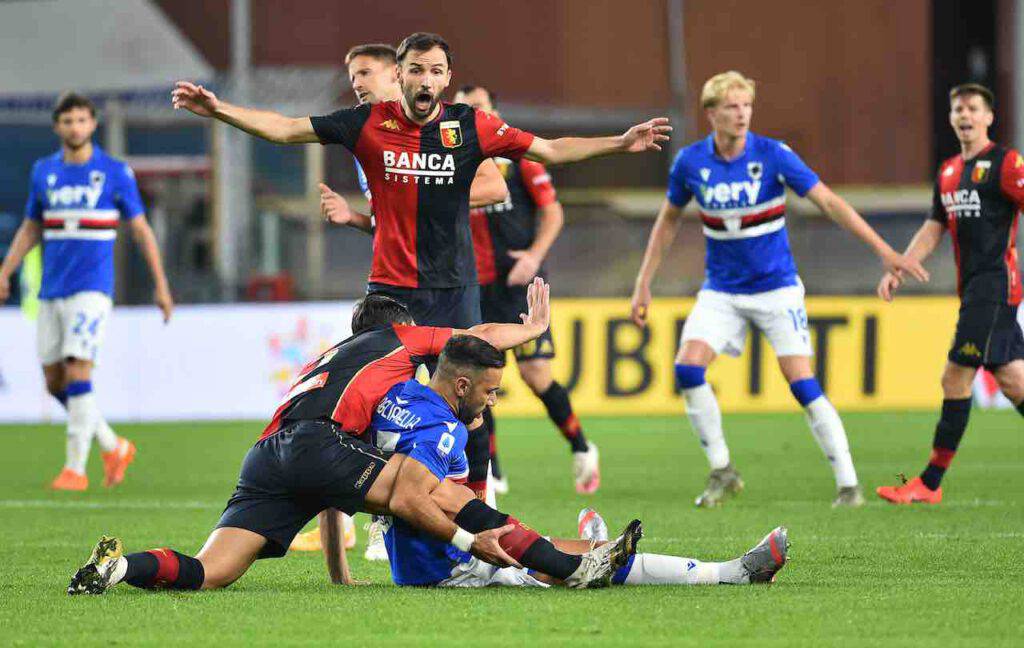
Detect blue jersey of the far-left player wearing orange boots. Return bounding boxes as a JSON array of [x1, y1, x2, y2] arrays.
[[25, 145, 143, 299]]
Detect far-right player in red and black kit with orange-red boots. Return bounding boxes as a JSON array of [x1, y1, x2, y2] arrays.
[[877, 83, 1024, 504]]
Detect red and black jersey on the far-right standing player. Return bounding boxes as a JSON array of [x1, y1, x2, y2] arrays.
[[930, 143, 1024, 306]]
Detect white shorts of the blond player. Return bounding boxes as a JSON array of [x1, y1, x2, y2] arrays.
[[681, 285, 814, 356]]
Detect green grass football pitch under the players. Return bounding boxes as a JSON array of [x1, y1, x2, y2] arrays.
[[0, 411, 1024, 646]]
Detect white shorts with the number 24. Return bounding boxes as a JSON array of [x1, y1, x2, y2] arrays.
[[37, 291, 111, 364]]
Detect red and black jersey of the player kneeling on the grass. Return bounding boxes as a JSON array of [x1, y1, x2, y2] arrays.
[[260, 325, 452, 439]]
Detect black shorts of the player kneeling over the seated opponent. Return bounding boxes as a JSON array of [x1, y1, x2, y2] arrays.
[[217, 421, 388, 558]]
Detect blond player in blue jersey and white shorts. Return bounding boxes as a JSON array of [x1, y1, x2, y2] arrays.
[[633, 72, 928, 506]]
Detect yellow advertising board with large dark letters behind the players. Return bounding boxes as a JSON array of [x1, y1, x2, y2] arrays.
[[498, 297, 958, 416]]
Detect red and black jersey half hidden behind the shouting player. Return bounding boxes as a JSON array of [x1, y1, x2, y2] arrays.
[[469, 158, 558, 286]]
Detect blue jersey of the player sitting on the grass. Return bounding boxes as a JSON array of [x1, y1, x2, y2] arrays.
[[370, 380, 469, 586]]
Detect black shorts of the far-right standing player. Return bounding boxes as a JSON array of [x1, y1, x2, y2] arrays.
[[948, 303, 1024, 370]]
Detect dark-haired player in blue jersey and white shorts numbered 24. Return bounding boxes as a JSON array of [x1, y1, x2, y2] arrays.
[[0, 93, 174, 490]]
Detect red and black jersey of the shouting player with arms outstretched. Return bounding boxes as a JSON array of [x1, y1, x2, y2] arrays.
[[310, 101, 534, 288]]
